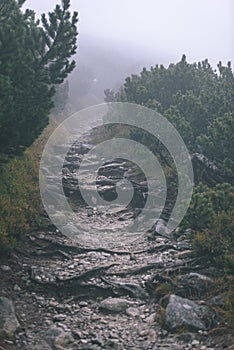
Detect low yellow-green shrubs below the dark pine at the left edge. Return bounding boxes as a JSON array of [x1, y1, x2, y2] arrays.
[[0, 154, 43, 253]]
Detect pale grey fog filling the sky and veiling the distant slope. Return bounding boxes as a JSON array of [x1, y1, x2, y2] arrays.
[[24, 0, 234, 104]]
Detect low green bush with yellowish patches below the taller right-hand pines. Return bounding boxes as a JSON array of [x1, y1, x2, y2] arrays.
[[182, 183, 234, 268]]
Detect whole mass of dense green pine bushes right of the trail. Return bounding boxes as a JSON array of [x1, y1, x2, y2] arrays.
[[110, 55, 234, 271]]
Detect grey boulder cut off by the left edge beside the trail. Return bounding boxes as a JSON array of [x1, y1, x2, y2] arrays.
[[0, 297, 20, 338]]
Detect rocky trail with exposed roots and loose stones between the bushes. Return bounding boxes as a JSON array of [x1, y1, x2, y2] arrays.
[[0, 136, 234, 350]]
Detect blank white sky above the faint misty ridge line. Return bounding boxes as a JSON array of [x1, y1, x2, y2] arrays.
[[26, 0, 234, 65]]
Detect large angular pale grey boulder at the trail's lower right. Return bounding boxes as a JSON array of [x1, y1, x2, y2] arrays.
[[164, 294, 215, 332]]
